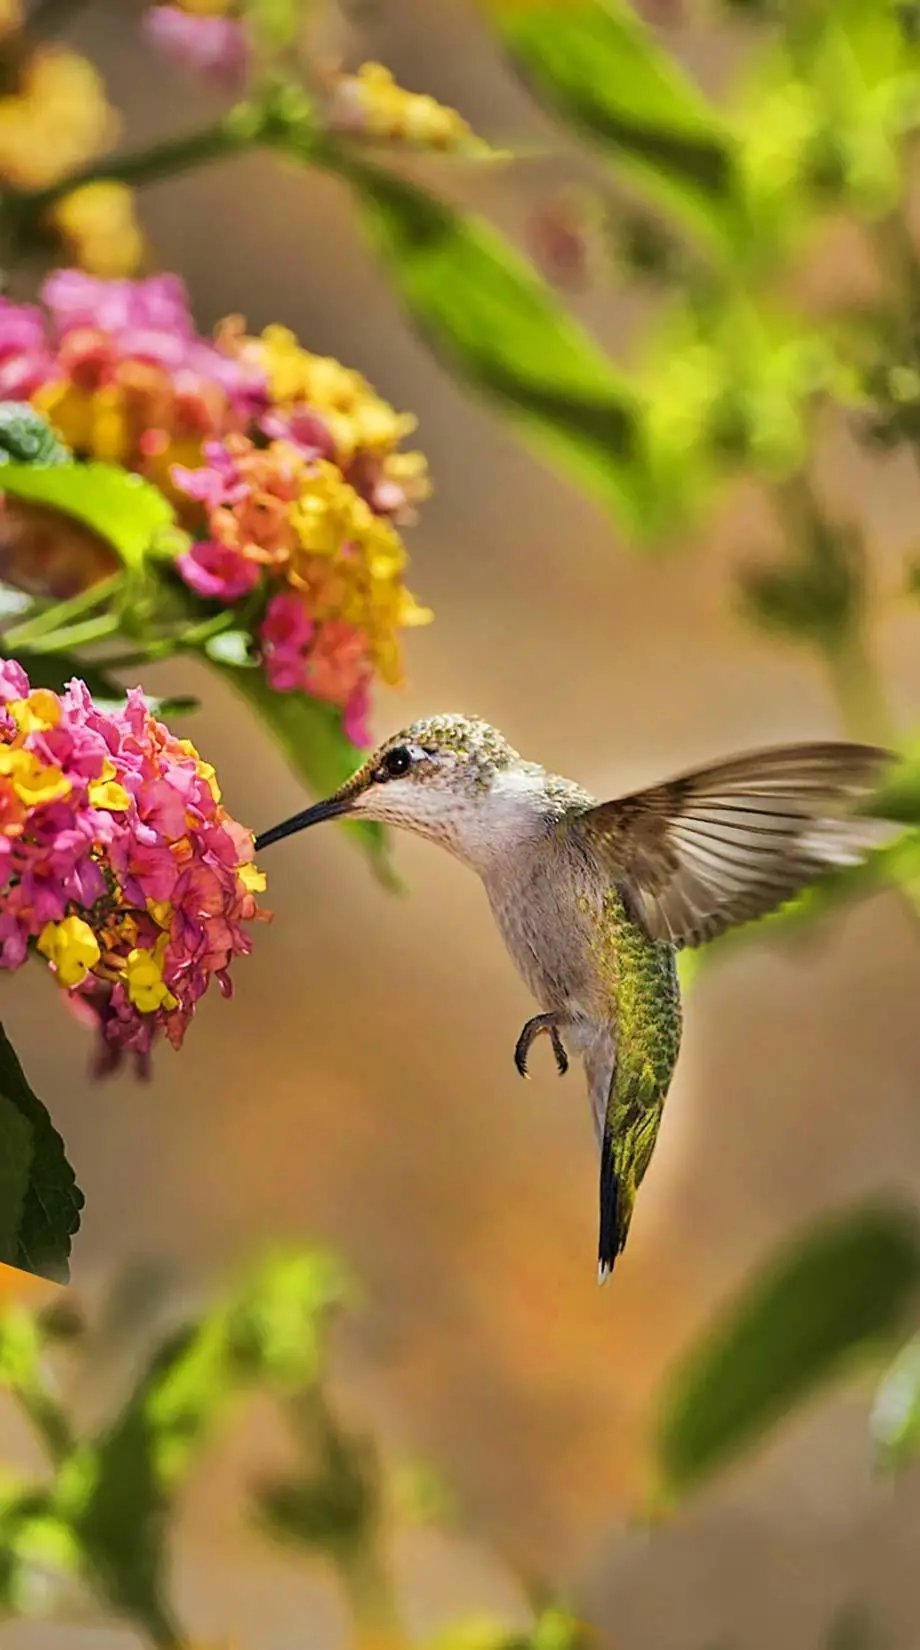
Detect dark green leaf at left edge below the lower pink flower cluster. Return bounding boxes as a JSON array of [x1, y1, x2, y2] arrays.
[[0, 1026, 84, 1284]]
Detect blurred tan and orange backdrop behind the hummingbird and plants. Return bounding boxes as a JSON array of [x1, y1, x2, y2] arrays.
[[9, 0, 920, 1650]]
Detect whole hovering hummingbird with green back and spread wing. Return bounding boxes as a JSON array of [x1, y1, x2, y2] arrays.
[[256, 716, 894, 1282]]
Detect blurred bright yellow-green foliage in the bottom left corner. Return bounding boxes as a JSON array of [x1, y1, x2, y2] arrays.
[[0, 1252, 348, 1645]]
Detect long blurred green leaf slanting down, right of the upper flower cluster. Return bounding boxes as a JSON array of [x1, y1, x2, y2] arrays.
[[320, 145, 668, 535]]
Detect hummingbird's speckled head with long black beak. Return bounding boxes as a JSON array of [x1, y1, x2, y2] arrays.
[[256, 716, 542, 868]]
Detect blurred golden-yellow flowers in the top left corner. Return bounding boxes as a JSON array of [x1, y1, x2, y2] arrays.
[[0, 16, 143, 276]]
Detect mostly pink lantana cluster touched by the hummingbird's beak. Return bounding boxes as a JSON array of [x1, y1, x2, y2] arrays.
[[0, 660, 267, 1074]]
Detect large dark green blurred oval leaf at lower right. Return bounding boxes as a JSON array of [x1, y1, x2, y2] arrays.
[[656, 1208, 920, 1495]]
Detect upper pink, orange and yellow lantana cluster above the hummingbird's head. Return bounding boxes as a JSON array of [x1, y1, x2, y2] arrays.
[[0, 271, 430, 744]]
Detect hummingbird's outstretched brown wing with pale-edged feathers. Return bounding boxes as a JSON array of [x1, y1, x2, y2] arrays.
[[572, 744, 895, 945]]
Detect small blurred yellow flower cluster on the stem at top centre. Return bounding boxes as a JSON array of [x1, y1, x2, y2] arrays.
[[326, 63, 486, 152]]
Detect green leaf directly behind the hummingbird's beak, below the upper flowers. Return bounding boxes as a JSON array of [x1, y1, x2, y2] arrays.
[[219, 660, 401, 891]]
